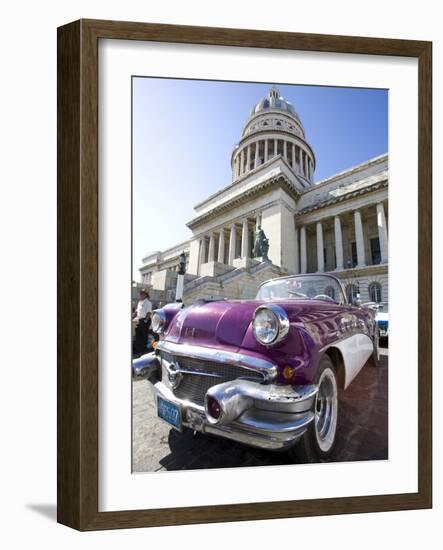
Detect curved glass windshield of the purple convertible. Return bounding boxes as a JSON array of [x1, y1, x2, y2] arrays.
[[257, 275, 346, 304]]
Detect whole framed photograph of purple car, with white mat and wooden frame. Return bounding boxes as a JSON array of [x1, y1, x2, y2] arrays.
[[58, 20, 432, 530]]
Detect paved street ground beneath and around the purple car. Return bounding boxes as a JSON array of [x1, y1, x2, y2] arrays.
[[133, 344, 388, 472]]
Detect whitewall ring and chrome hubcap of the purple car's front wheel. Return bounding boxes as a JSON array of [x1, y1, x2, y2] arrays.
[[315, 368, 338, 452]]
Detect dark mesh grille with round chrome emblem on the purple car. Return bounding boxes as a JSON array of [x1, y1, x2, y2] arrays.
[[160, 351, 264, 405]]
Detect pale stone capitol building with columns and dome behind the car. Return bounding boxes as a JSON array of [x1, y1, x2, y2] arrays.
[[140, 86, 388, 304]]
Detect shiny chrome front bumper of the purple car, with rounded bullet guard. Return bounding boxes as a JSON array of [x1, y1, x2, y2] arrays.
[[134, 354, 318, 450]]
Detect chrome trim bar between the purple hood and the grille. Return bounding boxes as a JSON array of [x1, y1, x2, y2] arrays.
[[156, 340, 278, 381]]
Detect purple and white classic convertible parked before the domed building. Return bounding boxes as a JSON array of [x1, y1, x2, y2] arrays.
[[133, 274, 378, 462]]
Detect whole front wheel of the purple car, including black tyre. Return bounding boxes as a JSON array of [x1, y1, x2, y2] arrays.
[[289, 356, 338, 462]]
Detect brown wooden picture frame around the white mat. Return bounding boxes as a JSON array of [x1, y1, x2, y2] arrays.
[[57, 20, 432, 530]]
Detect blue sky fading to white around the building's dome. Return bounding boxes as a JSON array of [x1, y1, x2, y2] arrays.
[[133, 77, 388, 280]]
